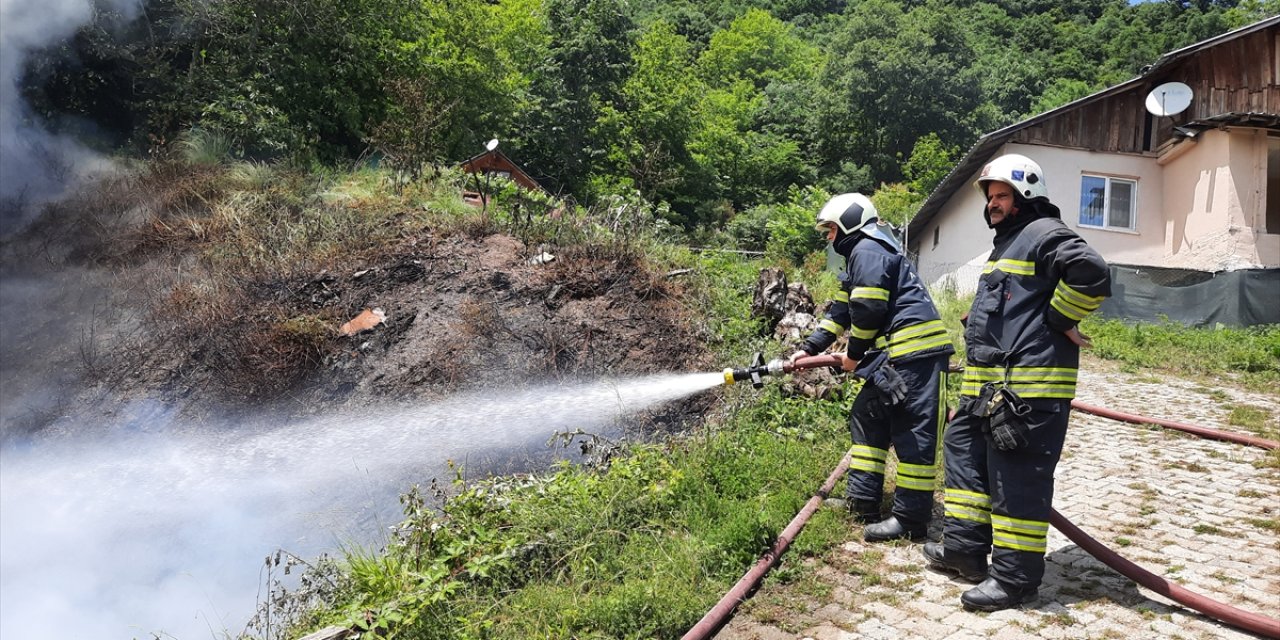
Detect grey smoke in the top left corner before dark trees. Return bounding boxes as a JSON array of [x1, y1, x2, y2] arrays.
[[0, 0, 141, 233]]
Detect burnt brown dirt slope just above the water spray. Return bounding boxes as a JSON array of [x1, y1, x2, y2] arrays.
[[0, 221, 716, 436]]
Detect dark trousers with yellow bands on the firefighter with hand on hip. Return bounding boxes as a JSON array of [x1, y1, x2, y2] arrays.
[[942, 397, 1071, 589]]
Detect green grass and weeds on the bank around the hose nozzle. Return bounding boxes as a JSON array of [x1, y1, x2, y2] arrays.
[[271, 238, 865, 639]]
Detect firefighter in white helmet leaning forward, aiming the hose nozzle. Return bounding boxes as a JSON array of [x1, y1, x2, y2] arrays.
[[790, 193, 955, 543]]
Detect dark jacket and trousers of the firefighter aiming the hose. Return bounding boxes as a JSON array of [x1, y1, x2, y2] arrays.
[[801, 233, 955, 526]]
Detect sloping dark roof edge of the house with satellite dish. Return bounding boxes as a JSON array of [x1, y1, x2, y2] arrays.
[[908, 15, 1280, 238]]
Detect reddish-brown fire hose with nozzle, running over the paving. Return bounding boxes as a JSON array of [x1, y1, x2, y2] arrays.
[[681, 353, 1280, 640]]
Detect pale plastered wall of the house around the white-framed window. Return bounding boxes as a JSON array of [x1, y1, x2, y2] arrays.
[[909, 135, 1280, 293]]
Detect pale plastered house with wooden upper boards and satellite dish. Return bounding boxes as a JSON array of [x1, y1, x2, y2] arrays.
[[906, 17, 1280, 325]]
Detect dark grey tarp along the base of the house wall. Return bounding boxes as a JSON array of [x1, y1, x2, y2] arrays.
[[1098, 265, 1280, 326]]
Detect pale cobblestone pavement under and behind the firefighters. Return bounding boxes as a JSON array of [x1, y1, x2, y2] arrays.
[[717, 362, 1280, 640]]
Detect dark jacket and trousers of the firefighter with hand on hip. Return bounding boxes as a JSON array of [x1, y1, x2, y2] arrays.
[[943, 202, 1111, 589]]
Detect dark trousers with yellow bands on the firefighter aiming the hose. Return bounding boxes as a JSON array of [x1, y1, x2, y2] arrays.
[[846, 353, 948, 526]]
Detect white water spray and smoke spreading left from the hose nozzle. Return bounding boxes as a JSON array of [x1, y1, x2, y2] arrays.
[[0, 374, 723, 640]]
